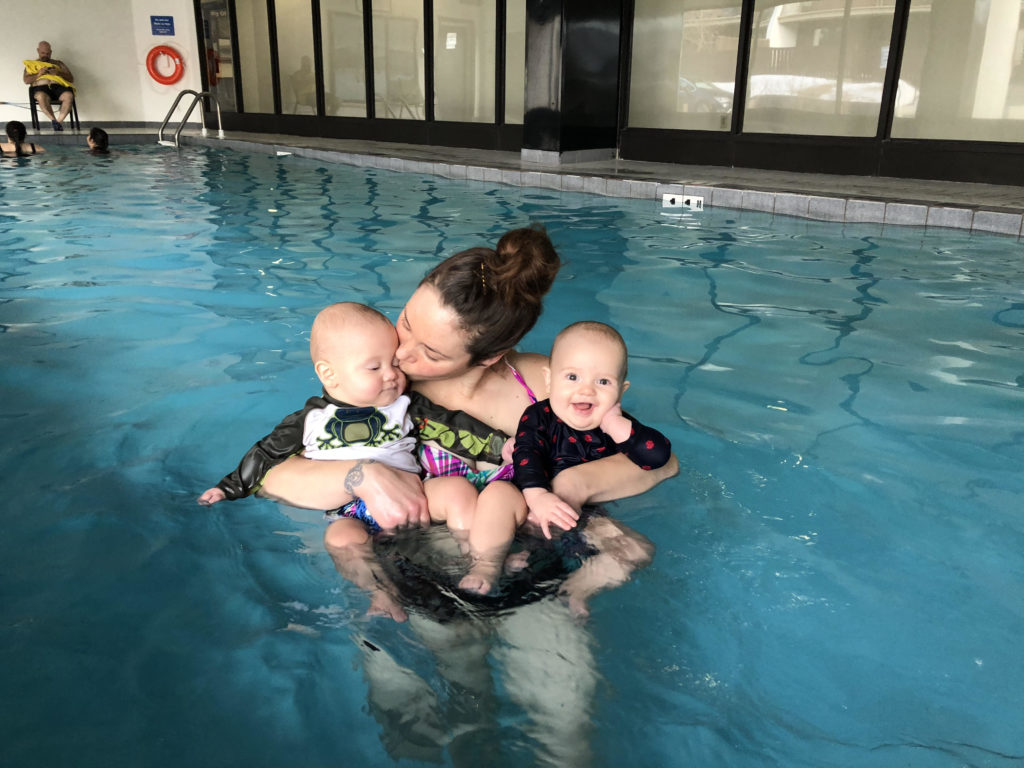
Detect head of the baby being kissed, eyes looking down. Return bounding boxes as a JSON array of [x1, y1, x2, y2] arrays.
[[309, 302, 406, 408]]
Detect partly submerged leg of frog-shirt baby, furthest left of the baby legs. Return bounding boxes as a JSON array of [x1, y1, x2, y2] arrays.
[[324, 517, 409, 622]]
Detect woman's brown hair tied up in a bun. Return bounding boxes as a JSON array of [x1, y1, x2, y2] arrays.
[[420, 224, 562, 366]]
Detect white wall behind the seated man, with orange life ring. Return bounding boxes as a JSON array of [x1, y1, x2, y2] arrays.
[[0, 0, 204, 127]]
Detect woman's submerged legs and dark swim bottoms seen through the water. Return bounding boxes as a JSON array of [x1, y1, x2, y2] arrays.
[[354, 526, 599, 767]]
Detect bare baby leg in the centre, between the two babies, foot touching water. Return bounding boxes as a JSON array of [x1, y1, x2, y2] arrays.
[[459, 480, 526, 595]]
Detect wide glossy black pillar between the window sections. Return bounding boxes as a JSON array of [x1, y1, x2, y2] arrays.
[[522, 0, 623, 162]]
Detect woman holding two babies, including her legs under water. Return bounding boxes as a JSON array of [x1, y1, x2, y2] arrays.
[[261, 222, 678, 766]]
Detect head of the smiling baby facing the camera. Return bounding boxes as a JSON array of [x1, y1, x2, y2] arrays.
[[547, 321, 630, 430]]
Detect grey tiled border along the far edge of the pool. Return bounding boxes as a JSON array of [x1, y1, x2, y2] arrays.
[[199, 138, 1024, 239]]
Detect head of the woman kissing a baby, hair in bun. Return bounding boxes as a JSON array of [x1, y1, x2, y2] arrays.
[[396, 225, 561, 380]]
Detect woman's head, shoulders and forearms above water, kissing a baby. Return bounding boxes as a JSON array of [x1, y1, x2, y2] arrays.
[[261, 222, 678, 536]]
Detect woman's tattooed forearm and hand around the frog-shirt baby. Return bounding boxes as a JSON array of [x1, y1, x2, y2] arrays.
[[259, 456, 430, 528]]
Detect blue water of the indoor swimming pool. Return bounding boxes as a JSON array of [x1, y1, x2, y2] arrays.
[[0, 147, 1024, 767]]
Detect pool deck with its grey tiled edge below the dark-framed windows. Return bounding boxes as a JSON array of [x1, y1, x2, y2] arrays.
[[34, 128, 1024, 239]]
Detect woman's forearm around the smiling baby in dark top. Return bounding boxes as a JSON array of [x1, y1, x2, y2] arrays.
[[552, 454, 679, 509]]
